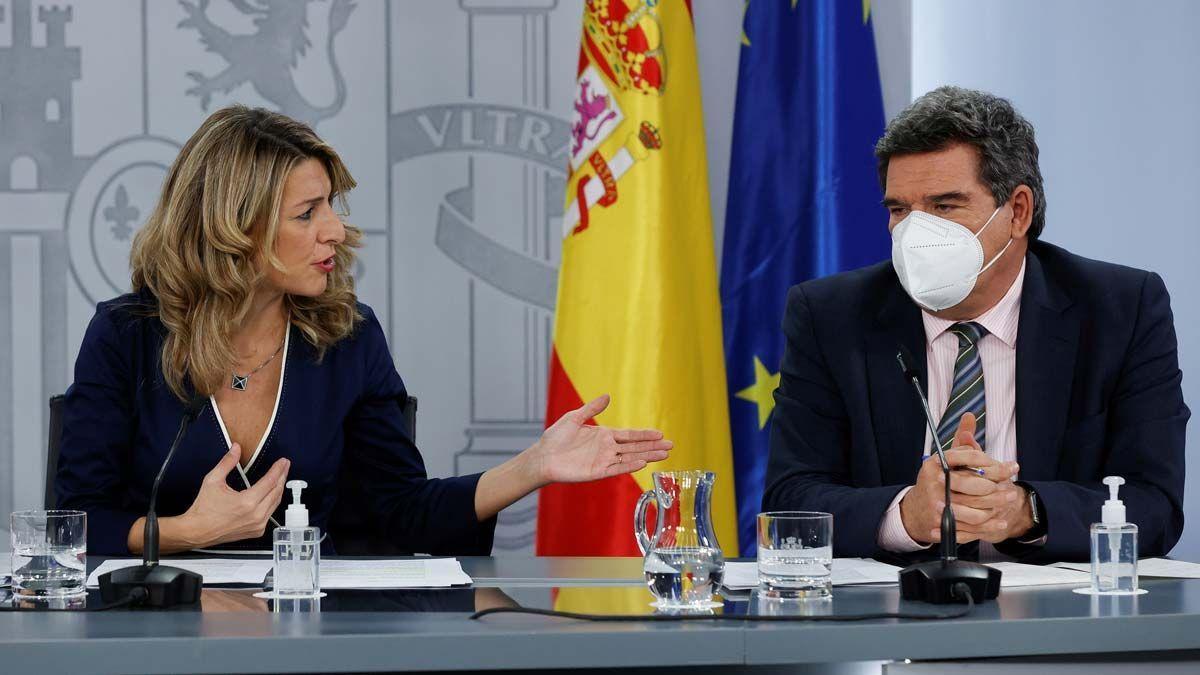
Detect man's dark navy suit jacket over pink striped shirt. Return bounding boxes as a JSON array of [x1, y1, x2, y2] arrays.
[[763, 241, 1190, 562]]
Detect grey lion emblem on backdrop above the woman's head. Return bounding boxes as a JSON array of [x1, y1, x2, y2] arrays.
[[179, 0, 354, 125]]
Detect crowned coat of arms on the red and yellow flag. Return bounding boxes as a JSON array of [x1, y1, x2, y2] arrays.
[[563, 0, 667, 238]]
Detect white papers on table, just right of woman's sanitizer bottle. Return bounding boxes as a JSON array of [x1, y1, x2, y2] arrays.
[[320, 557, 472, 589]]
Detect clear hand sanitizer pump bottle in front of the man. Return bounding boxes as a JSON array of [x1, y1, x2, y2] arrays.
[[1092, 476, 1138, 595]]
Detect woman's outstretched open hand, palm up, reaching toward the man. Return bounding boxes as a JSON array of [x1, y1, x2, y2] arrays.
[[529, 394, 673, 484]]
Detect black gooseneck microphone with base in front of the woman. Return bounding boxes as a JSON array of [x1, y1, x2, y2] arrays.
[[100, 395, 208, 608]]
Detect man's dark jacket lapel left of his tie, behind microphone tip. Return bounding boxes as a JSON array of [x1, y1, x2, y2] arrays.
[[866, 281, 928, 485]]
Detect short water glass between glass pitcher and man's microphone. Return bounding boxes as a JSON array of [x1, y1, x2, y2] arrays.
[[758, 510, 833, 598]]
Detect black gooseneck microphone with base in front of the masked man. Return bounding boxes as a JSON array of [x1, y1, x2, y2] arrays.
[[896, 345, 1001, 604]]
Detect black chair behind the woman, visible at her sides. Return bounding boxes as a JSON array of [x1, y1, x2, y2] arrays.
[[44, 394, 416, 555]]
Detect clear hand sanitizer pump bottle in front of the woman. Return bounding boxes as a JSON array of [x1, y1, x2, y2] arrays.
[[271, 480, 320, 598]]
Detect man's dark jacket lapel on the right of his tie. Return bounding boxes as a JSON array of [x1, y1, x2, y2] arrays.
[[1015, 247, 1079, 480]]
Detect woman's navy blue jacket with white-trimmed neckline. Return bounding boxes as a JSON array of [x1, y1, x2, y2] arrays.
[[55, 293, 496, 555]]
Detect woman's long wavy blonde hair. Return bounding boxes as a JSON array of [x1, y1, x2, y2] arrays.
[[130, 106, 362, 400]]
